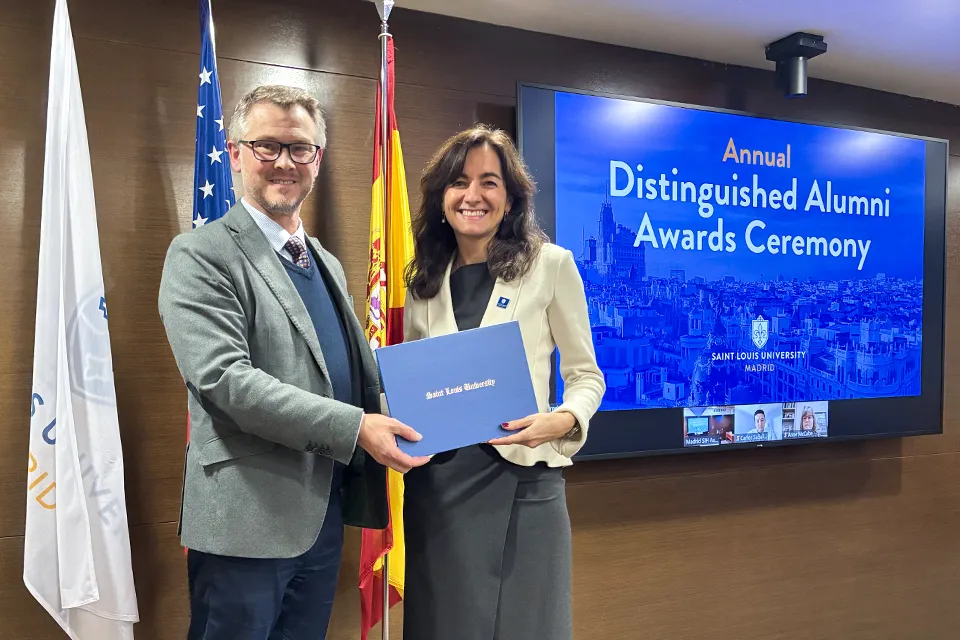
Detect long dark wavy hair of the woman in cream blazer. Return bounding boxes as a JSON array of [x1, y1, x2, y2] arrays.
[[404, 125, 547, 298]]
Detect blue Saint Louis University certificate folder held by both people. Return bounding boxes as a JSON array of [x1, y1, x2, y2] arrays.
[[374, 321, 538, 456]]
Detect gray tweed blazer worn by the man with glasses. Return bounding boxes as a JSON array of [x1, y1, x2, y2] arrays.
[[159, 203, 388, 558]]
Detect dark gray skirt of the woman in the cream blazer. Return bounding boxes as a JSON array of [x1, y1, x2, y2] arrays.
[[403, 444, 573, 640]]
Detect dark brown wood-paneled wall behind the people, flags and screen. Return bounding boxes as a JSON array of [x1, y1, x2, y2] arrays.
[[0, 0, 960, 640]]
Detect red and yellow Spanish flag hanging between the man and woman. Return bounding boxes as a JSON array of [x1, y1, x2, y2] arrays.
[[360, 35, 413, 640]]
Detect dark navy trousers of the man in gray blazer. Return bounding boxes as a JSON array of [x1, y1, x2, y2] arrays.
[[187, 488, 343, 640]]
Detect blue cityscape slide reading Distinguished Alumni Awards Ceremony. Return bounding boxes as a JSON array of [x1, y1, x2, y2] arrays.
[[555, 92, 925, 410]]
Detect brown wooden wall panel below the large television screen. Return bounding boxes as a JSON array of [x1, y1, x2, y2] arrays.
[[568, 454, 960, 640]]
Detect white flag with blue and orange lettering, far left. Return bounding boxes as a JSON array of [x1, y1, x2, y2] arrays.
[[23, 0, 139, 640]]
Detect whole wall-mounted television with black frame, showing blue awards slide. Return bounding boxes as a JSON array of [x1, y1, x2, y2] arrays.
[[517, 83, 948, 458]]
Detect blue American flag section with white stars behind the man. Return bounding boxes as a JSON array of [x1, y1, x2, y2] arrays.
[[193, 0, 236, 228]]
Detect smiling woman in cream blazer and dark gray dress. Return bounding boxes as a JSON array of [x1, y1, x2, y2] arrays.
[[403, 126, 605, 640]]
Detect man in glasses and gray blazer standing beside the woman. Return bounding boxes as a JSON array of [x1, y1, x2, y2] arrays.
[[159, 86, 427, 640]]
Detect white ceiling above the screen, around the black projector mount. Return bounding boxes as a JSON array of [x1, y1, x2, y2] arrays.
[[396, 0, 960, 105]]
